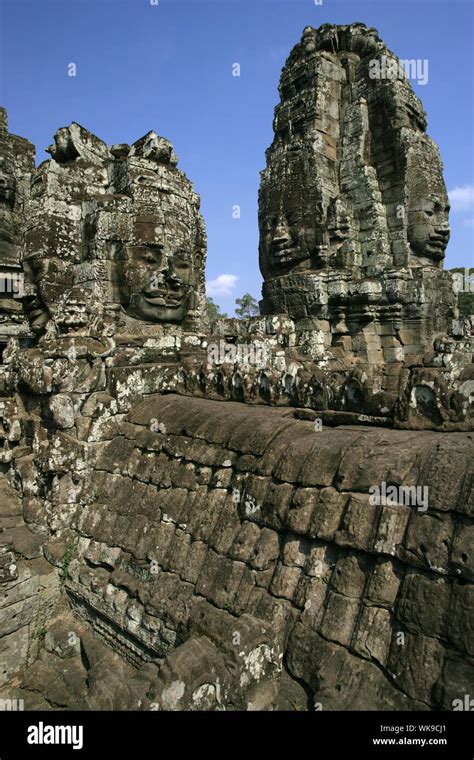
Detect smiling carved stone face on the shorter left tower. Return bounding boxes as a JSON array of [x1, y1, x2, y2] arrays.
[[118, 209, 202, 322]]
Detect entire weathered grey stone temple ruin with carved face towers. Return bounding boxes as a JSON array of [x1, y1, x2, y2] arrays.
[[0, 23, 474, 710]]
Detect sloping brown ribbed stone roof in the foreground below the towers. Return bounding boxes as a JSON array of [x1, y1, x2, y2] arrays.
[[8, 395, 474, 709]]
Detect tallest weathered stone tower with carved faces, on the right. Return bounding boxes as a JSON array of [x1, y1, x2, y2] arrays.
[[259, 23, 455, 364]]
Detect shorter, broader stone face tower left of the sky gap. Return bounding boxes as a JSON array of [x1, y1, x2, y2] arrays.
[[20, 122, 206, 335]]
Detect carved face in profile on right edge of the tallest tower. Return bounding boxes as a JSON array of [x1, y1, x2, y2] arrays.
[[408, 195, 450, 261]]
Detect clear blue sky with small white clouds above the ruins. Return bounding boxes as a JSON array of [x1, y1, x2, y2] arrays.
[[0, 0, 474, 313]]
